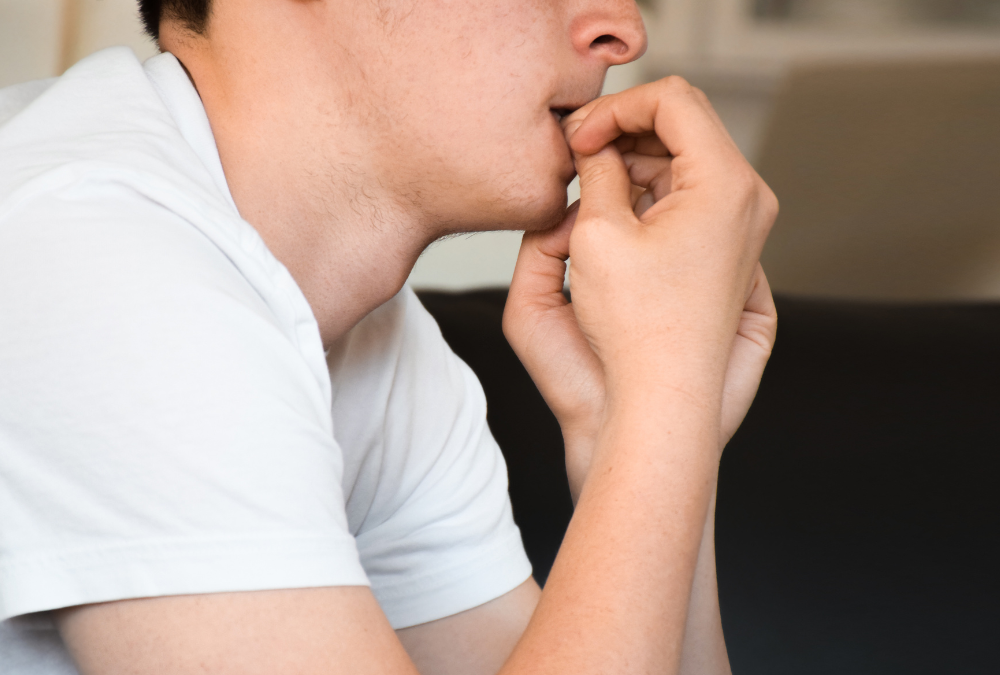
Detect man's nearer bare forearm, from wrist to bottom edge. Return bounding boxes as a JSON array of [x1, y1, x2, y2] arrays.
[[503, 395, 718, 673]]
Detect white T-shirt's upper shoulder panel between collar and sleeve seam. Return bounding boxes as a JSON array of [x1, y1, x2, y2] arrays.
[[0, 48, 229, 227]]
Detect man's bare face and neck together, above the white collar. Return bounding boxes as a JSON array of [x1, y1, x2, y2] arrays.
[[161, 0, 646, 343]]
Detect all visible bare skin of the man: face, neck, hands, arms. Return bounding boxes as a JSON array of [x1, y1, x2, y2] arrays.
[[57, 0, 777, 675]]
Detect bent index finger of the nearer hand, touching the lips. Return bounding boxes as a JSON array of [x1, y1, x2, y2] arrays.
[[566, 77, 734, 165]]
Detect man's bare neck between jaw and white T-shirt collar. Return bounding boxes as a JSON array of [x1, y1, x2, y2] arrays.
[[161, 23, 436, 347]]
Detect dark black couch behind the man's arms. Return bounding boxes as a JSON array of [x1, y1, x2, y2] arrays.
[[421, 290, 1000, 675]]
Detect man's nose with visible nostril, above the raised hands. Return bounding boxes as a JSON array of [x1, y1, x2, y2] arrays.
[[570, 0, 647, 66]]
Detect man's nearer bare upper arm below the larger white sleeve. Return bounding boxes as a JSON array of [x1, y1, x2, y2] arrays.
[[57, 586, 417, 675]]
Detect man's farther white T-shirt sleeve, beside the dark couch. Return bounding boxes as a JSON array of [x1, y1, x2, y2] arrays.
[[334, 288, 531, 628]]
